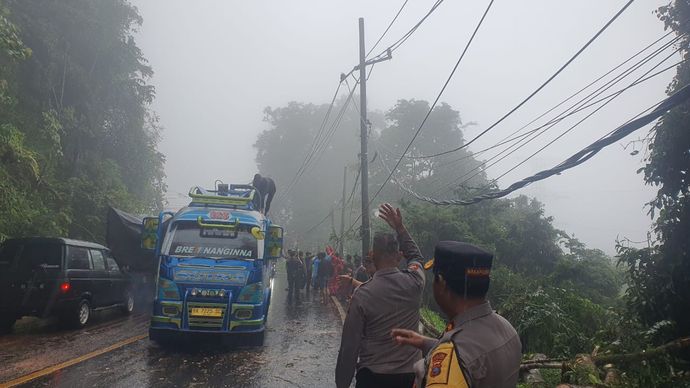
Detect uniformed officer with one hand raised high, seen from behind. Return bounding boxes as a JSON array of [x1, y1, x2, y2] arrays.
[[335, 204, 425, 388]]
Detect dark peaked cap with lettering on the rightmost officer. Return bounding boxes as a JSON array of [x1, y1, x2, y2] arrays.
[[424, 241, 494, 297]]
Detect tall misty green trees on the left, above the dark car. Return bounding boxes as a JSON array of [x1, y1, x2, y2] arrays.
[[0, 0, 165, 241]]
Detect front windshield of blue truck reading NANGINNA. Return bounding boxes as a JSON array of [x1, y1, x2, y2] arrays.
[[167, 222, 257, 260]]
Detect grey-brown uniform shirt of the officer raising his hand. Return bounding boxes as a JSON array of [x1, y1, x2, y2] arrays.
[[335, 231, 424, 388]]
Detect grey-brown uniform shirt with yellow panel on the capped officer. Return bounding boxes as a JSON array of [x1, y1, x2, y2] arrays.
[[415, 302, 522, 388]]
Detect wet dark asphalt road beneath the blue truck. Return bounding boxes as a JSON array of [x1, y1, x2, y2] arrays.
[[0, 262, 341, 388]]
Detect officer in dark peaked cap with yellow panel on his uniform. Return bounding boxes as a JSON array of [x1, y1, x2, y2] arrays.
[[392, 241, 521, 388]]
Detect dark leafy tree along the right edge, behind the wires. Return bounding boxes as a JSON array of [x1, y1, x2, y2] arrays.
[[619, 0, 690, 336]]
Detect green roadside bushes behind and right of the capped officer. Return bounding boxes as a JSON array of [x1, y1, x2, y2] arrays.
[[403, 196, 623, 356]]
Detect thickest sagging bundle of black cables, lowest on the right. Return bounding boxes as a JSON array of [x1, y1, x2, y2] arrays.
[[378, 85, 690, 205]]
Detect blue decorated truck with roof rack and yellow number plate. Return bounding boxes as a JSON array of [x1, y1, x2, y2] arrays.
[[141, 184, 283, 343]]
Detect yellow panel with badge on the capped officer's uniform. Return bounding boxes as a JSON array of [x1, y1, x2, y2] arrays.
[[426, 342, 469, 388]]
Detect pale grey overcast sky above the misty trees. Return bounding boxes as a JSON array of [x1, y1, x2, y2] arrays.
[[133, 0, 677, 253]]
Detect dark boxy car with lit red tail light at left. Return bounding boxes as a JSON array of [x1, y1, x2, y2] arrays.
[[0, 237, 134, 331]]
